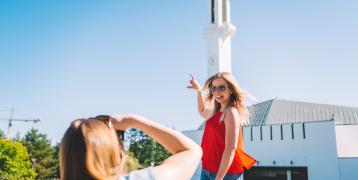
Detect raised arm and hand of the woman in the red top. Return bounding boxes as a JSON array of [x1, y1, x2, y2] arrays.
[[187, 74, 212, 119]]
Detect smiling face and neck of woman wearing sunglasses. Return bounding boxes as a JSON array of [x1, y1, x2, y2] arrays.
[[211, 78, 232, 112]]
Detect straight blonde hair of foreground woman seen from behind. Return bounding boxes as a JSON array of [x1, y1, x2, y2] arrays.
[[60, 118, 125, 180]]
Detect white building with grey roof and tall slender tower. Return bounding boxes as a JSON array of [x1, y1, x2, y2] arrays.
[[184, 0, 358, 180]]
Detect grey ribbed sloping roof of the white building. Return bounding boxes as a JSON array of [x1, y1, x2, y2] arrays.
[[198, 99, 358, 129]]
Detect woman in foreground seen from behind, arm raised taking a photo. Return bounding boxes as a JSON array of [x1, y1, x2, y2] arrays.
[[60, 115, 202, 180]]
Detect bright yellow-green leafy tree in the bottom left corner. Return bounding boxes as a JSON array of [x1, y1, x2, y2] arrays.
[[0, 138, 36, 180]]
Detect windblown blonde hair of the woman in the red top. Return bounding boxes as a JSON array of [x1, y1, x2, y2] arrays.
[[204, 72, 250, 125]]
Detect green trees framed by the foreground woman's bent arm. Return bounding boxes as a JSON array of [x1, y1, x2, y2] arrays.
[[126, 129, 171, 168]]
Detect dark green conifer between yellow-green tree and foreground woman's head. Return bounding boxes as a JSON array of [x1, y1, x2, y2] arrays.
[[22, 129, 58, 179]]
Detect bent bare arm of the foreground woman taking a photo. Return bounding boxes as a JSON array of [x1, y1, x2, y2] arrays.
[[111, 115, 202, 180]]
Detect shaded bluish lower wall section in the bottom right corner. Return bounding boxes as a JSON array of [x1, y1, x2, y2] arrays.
[[338, 158, 358, 180]]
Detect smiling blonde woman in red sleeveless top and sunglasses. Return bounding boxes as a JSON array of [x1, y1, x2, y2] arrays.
[[188, 72, 256, 180]]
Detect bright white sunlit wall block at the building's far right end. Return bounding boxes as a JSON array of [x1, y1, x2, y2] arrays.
[[336, 125, 358, 158]]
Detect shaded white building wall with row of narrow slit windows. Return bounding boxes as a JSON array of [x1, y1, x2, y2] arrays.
[[244, 121, 339, 180]]
